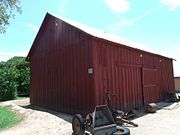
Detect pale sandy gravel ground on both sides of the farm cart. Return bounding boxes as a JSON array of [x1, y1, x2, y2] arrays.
[[0, 99, 180, 135]]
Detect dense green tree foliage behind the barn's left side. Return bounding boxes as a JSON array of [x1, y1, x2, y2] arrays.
[[0, 57, 30, 100]]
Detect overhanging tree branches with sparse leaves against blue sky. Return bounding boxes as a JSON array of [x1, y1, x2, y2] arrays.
[[0, 0, 21, 33]]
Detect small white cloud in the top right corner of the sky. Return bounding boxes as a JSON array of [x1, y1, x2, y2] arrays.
[[160, 0, 180, 11]]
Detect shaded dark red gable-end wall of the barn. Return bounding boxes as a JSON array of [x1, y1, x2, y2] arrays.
[[30, 16, 94, 113]]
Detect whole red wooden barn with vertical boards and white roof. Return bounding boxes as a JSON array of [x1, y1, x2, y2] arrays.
[[27, 13, 174, 114]]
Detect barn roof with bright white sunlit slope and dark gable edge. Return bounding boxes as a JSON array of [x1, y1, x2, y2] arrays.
[[27, 13, 172, 59]]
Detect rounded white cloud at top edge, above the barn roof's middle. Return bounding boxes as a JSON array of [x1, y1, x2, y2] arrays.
[[105, 0, 130, 13]]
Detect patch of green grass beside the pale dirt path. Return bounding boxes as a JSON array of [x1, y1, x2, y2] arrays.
[[0, 106, 24, 130]]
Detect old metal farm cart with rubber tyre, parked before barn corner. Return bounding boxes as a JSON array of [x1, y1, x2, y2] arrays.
[[72, 105, 130, 135]]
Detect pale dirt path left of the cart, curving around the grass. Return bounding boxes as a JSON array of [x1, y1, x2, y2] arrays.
[[0, 99, 72, 135]]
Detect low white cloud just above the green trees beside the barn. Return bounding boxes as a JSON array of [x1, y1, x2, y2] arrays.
[[0, 51, 28, 62]]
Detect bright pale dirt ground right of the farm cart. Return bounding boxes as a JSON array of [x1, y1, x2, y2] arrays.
[[130, 102, 180, 135]]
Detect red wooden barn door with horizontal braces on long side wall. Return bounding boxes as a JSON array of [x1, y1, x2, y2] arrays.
[[142, 68, 159, 105]]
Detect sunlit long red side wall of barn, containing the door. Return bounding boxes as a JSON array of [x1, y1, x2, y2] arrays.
[[93, 38, 174, 110]]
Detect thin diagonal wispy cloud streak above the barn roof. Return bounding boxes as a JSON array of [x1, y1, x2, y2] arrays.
[[109, 7, 160, 31]]
